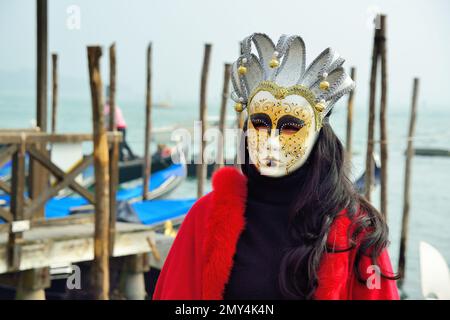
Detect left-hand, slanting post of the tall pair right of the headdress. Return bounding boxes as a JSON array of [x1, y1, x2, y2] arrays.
[[365, 18, 380, 201]]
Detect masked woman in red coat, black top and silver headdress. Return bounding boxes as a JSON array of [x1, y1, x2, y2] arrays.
[[153, 34, 399, 299]]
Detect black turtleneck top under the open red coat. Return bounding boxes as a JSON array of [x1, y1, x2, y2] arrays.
[[224, 165, 304, 299]]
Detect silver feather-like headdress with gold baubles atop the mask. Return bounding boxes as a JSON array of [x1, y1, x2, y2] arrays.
[[231, 33, 355, 128]]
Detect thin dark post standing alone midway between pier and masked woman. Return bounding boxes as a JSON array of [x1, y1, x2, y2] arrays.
[[142, 43, 152, 200]]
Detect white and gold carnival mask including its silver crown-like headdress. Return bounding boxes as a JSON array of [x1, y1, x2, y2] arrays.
[[232, 33, 354, 177]]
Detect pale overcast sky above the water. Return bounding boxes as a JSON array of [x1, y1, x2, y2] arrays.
[[0, 0, 450, 107]]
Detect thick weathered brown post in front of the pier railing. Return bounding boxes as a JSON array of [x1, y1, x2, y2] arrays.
[[87, 46, 109, 300]]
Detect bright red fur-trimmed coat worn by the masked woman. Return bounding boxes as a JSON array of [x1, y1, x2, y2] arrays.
[[153, 168, 399, 300]]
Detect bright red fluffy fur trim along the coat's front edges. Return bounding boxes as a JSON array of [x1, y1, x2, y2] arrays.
[[202, 167, 350, 300]]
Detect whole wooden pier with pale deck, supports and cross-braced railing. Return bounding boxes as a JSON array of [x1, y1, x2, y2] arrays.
[[0, 130, 167, 299]]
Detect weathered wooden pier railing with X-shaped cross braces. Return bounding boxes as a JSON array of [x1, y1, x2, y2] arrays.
[[0, 131, 122, 271]]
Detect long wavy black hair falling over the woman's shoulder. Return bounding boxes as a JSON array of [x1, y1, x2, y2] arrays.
[[268, 123, 397, 299]]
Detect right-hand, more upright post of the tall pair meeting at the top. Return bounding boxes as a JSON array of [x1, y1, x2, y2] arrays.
[[379, 15, 388, 219]]
